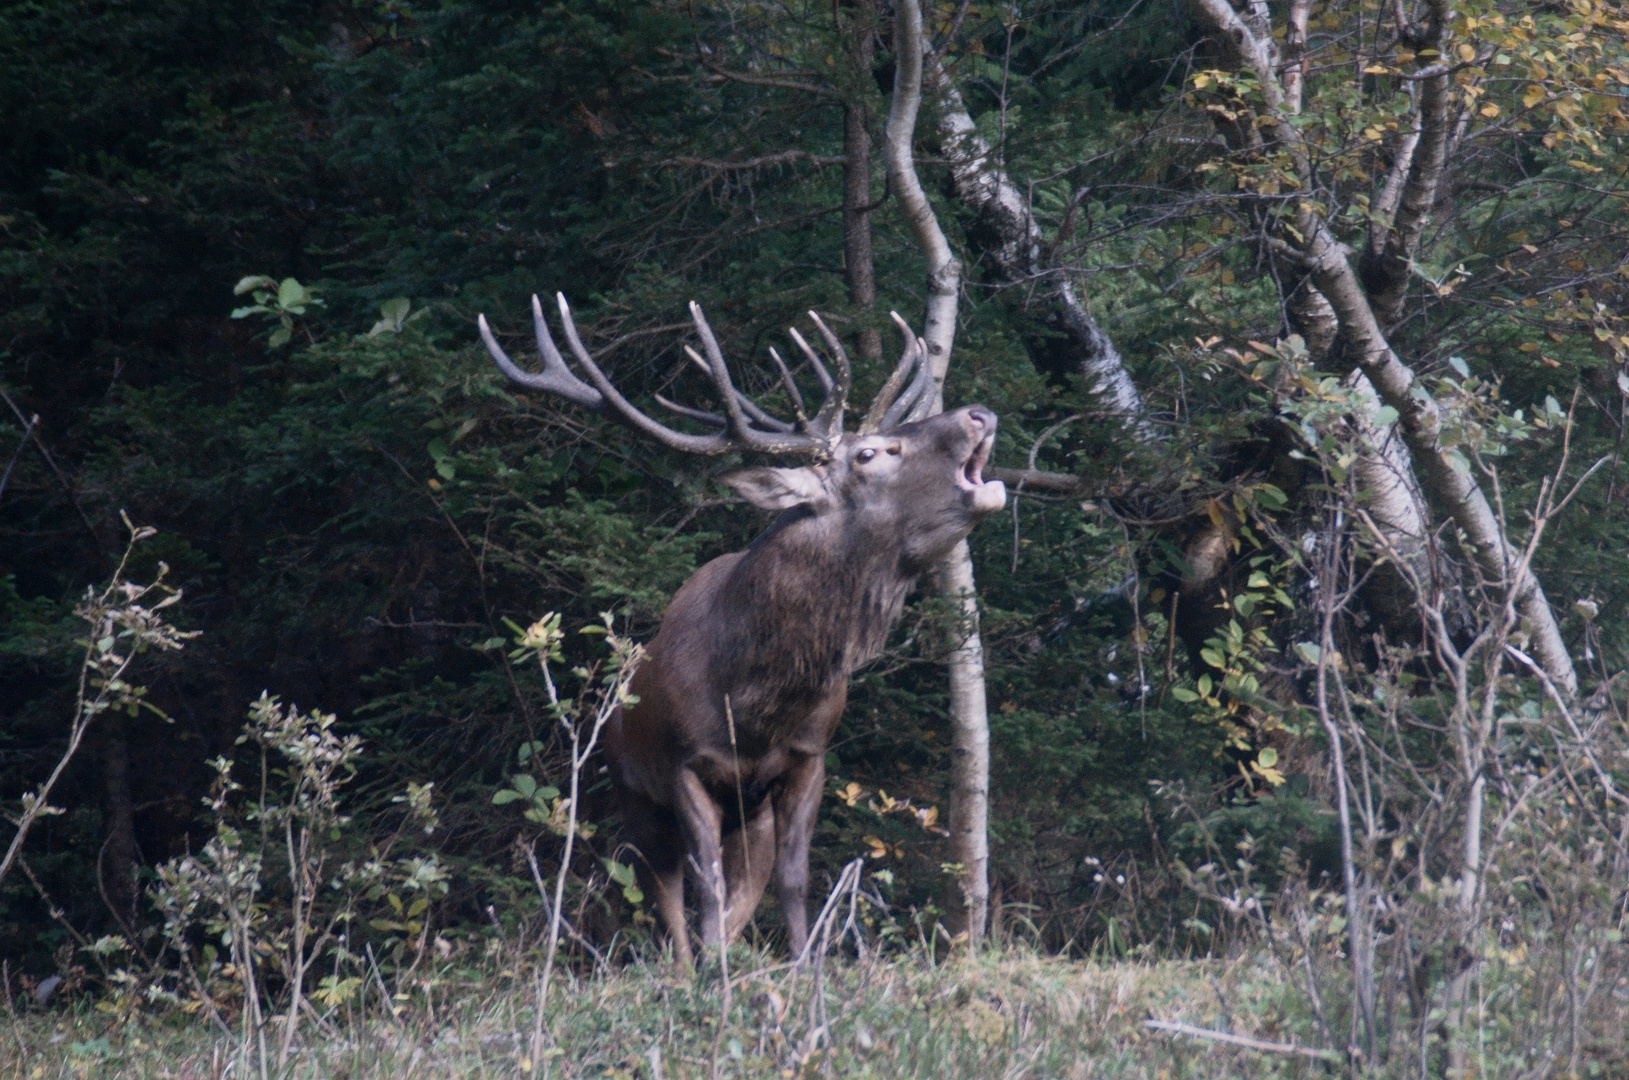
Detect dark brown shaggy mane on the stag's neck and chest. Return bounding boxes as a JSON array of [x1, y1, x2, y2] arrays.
[[714, 510, 915, 735]]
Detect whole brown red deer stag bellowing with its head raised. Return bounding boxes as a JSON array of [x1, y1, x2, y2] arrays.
[[479, 296, 1007, 966]]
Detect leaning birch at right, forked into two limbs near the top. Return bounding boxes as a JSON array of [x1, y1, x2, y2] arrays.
[[1197, 0, 1579, 696]]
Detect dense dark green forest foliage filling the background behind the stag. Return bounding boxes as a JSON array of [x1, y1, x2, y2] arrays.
[[0, 0, 1629, 1022]]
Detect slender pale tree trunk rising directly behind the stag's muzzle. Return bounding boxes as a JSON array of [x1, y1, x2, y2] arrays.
[[886, 0, 990, 945]]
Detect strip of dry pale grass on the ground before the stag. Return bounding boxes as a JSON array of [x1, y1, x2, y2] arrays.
[[0, 950, 1459, 1080]]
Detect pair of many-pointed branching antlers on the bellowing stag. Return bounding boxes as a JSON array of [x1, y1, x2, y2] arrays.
[[477, 293, 933, 458]]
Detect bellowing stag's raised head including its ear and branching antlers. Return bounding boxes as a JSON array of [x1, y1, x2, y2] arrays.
[[479, 295, 1007, 573]]
